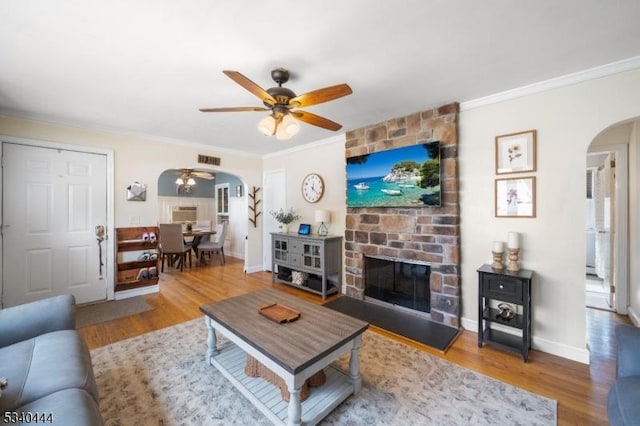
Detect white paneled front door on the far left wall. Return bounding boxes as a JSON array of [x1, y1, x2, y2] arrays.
[[2, 143, 107, 307]]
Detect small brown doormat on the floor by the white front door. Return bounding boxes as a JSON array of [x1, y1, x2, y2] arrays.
[[76, 296, 153, 328]]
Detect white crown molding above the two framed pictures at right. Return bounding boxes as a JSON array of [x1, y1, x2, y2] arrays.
[[460, 56, 640, 112]]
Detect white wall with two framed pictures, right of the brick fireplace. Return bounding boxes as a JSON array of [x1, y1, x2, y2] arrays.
[[459, 70, 640, 362]]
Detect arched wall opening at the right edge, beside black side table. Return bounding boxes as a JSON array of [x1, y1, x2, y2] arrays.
[[585, 117, 640, 325]]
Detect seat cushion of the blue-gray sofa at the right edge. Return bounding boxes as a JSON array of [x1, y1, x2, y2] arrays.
[[607, 376, 640, 426]]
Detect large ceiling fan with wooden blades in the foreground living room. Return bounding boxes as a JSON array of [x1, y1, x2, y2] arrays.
[[200, 68, 352, 139]]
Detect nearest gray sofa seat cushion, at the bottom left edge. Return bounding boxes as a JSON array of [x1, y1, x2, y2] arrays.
[[12, 388, 104, 426]]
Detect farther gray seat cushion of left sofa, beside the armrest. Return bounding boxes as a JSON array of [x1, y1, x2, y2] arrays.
[[0, 330, 98, 412]]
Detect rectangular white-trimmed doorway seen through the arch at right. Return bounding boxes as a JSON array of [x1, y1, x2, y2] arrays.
[[585, 144, 629, 314]]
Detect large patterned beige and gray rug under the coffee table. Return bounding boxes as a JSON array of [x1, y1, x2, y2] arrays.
[[91, 319, 557, 426]]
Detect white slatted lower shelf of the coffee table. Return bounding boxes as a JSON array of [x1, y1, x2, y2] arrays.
[[211, 344, 353, 425]]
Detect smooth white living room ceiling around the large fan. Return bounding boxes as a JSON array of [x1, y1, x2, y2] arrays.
[[0, 0, 640, 155]]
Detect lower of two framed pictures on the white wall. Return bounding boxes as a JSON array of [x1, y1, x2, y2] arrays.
[[495, 176, 536, 217]]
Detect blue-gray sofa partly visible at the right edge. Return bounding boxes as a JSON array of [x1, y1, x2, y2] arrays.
[[607, 325, 640, 426]]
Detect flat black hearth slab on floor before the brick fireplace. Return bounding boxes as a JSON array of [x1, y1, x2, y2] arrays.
[[323, 296, 460, 352]]
